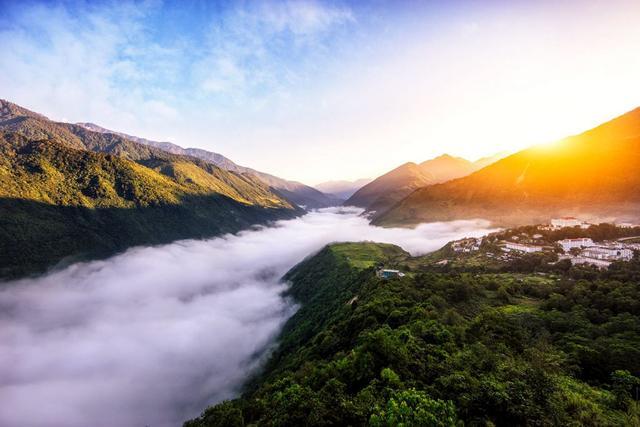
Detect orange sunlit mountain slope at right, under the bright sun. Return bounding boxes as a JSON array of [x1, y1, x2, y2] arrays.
[[374, 108, 640, 226]]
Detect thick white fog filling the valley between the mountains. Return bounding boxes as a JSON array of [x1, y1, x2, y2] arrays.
[[0, 209, 496, 427]]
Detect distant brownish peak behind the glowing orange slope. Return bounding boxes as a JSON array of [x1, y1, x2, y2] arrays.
[[344, 154, 495, 212]]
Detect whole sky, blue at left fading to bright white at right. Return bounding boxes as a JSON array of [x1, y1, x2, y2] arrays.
[[0, 0, 640, 184]]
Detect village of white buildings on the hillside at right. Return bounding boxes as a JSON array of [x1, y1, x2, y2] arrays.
[[448, 217, 640, 268]]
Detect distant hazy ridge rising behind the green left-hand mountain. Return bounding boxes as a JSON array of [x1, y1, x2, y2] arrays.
[[78, 123, 341, 209]]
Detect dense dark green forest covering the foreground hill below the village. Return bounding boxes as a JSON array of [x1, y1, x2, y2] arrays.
[[185, 243, 640, 427]]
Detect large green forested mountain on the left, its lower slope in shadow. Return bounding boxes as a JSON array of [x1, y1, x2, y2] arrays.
[[0, 100, 302, 277]]
